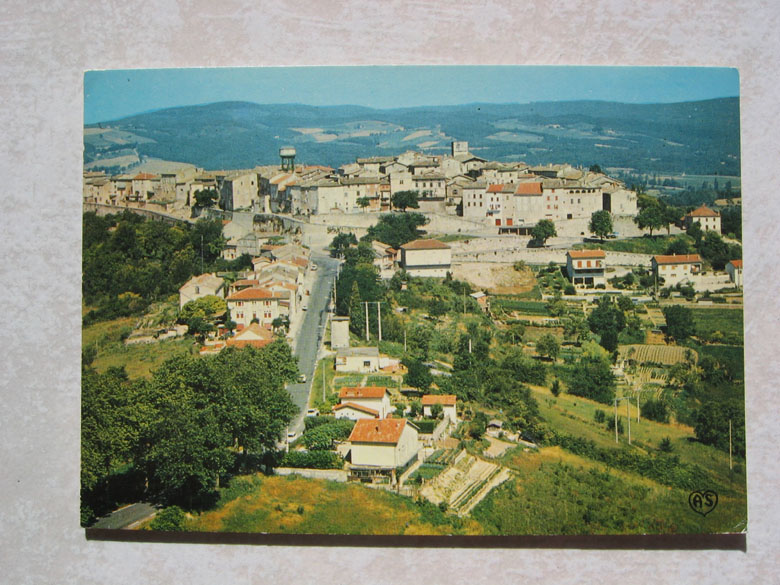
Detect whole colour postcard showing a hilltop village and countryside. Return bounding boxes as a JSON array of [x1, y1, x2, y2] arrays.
[[80, 66, 747, 545]]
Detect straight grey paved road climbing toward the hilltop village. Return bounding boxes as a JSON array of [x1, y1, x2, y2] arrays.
[[287, 252, 339, 433]]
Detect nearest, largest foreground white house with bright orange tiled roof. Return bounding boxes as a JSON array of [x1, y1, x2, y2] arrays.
[[349, 418, 420, 473]]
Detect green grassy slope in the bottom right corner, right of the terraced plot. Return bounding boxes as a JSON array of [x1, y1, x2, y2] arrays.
[[472, 447, 747, 534]]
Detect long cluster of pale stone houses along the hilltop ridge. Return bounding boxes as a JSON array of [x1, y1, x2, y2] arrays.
[[84, 141, 637, 230]]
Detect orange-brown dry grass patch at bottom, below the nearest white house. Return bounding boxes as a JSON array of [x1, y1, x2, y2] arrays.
[[185, 475, 481, 534]]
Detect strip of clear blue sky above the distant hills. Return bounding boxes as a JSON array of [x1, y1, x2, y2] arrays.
[[84, 66, 739, 124]]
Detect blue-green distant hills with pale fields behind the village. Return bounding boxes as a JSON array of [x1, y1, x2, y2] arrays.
[[84, 98, 740, 176]]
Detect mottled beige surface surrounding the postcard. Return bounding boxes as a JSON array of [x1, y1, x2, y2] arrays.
[[0, 0, 780, 585]]
